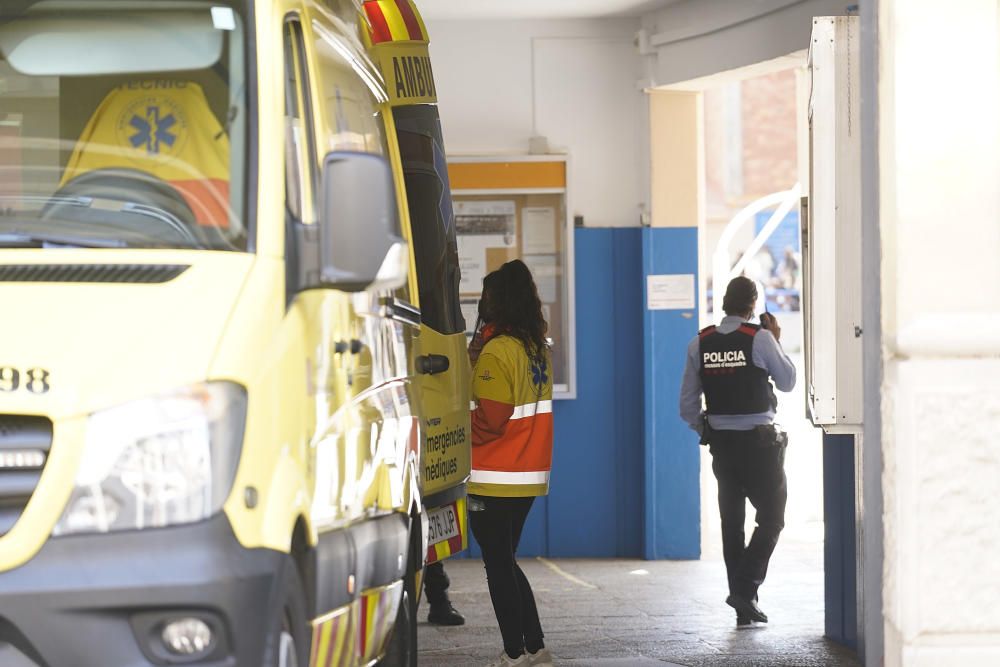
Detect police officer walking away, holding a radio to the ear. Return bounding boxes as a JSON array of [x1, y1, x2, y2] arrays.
[[680, 276, 795, 627]]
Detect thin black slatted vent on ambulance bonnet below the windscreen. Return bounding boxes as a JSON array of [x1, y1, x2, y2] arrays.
[[0, 264, 188, 283]]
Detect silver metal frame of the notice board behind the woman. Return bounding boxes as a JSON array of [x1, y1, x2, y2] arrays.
[[448, 155, 576, 400]]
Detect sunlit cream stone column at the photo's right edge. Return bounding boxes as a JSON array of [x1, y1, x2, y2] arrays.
[[878, 0, 1000, 667]]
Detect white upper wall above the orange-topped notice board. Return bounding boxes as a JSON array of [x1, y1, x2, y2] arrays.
[[427, 19, 649, 227]]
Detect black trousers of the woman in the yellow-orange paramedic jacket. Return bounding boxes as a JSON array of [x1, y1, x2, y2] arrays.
[[469, 496, 545, 658]]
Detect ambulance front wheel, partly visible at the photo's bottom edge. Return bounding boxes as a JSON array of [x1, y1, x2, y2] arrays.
[[262, 558, 310, 667]]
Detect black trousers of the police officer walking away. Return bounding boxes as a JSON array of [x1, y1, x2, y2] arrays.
[[711, 431, 788, 600]]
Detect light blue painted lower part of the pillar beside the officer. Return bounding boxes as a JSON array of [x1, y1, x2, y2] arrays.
[[642, 228, 701, 559]]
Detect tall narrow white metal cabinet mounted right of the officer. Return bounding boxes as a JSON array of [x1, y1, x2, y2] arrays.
[[802, 16, 864, 433]]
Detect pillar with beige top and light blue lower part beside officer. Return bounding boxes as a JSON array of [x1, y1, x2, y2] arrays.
[[642, 91, 704, 559]]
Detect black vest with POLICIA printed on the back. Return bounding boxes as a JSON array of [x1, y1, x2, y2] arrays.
[[698, 323, 778, 415]]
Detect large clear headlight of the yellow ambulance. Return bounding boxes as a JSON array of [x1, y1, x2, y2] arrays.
[[53, 382, 247, 535]]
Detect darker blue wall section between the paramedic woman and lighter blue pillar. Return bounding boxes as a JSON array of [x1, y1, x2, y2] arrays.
[[469, 228, 643, 557]]
